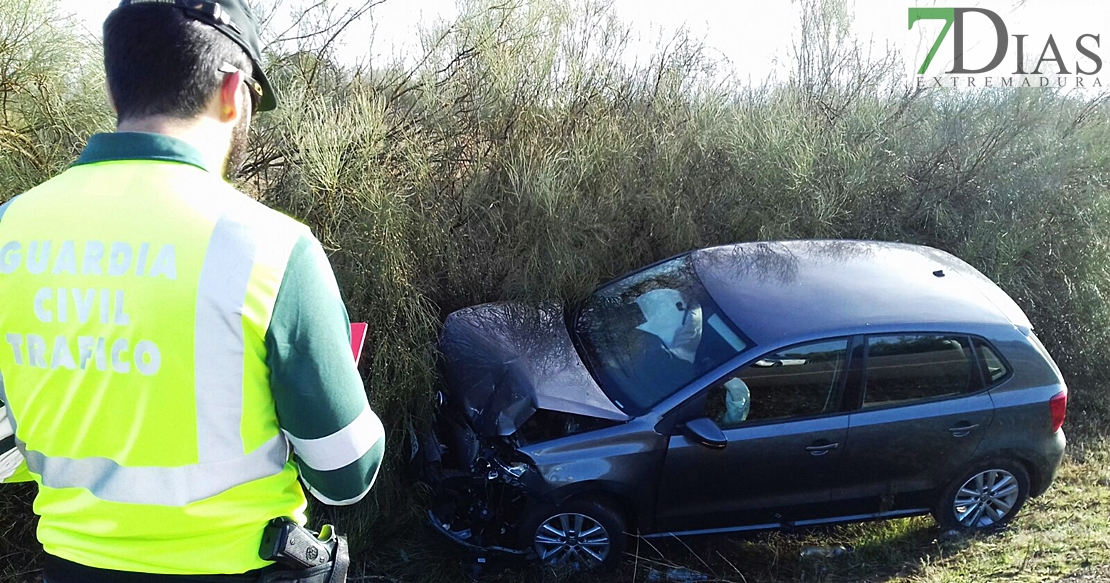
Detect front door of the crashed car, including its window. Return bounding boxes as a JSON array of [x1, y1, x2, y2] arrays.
[[656, 339, 849, 532]]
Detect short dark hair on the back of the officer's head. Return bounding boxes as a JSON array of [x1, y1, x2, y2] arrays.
[[104, 6, 252, 121]]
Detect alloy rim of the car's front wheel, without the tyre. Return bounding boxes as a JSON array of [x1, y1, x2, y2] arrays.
[[534, 512, 612, 565]]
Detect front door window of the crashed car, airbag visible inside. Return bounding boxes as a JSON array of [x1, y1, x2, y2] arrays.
[[705, 339, 848, 429]]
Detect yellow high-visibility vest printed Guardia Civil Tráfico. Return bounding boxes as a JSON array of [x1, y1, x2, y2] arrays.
[[0, 138, 306, 574]]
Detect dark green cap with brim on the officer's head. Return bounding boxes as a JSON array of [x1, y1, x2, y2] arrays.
[[120, 0, 278, 111]]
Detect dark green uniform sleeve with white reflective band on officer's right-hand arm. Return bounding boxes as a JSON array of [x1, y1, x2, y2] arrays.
[[266, 235, 385, 504]]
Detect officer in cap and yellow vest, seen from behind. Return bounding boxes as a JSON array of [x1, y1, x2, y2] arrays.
[[0, 0, 384, 583]]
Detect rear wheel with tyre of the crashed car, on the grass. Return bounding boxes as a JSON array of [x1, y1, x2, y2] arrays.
[[932, 460, 1029, 531]]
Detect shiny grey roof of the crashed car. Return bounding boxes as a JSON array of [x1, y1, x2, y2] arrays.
[[692, 241, 1031, 344]]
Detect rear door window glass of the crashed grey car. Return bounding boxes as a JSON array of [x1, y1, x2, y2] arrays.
[[864, 334, 977, 409]]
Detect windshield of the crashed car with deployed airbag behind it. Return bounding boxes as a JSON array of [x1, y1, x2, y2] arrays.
[[573, 255, 748, 414]]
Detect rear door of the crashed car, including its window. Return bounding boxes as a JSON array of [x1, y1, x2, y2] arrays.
[[834, 333, 993, 514]]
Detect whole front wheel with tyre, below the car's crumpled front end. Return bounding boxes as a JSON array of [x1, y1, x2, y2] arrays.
[[519, 500, 627, 571]]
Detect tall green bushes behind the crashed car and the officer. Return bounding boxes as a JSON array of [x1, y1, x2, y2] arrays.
[[0, 0, 1110, 577]]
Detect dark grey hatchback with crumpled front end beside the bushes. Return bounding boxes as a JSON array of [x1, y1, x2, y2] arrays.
[[415, 241, 1067, 567]]
